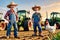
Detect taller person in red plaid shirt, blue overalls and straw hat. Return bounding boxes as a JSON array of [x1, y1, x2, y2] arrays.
[[4, 2, 18, 38]]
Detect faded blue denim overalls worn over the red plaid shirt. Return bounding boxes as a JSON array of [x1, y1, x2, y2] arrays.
[[7, 12, 17, 37]]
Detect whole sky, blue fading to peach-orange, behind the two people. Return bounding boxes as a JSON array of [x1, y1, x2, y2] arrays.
[[0, 0, 60, 19]]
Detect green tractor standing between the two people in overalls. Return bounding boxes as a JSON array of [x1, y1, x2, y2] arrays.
[[17, 10, 30, 31]]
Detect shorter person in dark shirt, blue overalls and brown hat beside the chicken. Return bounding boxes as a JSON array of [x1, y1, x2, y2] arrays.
[[32, 6, 43, 37]]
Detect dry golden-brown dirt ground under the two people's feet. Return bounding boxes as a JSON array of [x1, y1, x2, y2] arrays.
[[0, 29, 60, 40]]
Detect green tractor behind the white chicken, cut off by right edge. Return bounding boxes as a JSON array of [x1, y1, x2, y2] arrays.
[[48, 12, 60, 29]]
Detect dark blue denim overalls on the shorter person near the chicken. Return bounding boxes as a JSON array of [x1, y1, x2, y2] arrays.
[[32, 13, 42, 33]]
